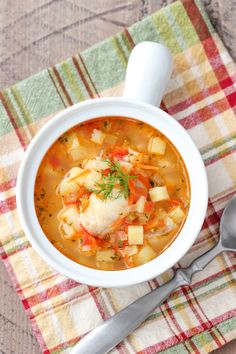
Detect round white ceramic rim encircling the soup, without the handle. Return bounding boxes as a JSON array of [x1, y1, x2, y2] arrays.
[[16, 97, 208, 287]]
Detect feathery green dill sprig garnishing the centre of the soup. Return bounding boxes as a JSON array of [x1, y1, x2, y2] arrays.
[[91, 160, 137, 199]]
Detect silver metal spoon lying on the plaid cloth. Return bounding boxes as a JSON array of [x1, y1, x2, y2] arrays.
[[71, 196, 236, 354]]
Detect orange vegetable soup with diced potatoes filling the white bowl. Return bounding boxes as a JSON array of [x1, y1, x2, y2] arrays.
[[34, 117, 190, 270]]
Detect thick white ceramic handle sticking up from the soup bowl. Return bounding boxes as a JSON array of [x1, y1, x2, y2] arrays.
[[123, 42, 173, 106]]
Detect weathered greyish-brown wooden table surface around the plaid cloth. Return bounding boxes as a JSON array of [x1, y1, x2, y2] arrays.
[[0, 0, 236, 354]]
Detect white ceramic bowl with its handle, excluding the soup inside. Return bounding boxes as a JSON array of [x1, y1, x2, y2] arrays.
[[17, 42, 208, 287]]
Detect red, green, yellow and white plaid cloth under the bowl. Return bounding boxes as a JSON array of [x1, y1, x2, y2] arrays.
[[0, 0, 236, 354]]
